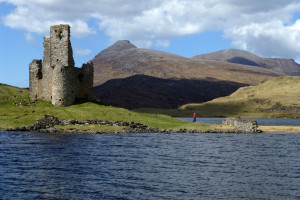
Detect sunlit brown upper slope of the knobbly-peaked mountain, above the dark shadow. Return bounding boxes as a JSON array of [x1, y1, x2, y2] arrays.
[[92, 40, 282, 86]]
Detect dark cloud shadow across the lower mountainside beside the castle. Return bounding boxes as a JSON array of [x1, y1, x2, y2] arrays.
[[94, 75, 247, 109]]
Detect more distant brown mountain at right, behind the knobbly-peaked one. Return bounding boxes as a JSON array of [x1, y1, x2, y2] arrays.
[[193, 49, 300, 76]]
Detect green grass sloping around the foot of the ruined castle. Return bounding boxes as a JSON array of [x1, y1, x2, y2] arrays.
[[0, 85, 211, 131]]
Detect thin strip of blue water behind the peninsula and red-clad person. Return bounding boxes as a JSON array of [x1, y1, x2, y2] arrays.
[[176, 117, 300, 126]]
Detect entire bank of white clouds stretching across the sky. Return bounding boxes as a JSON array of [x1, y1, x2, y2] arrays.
[[0, 0, 300, 57]]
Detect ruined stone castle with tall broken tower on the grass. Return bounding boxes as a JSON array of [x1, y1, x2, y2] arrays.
[[29, 24, 94, 106]]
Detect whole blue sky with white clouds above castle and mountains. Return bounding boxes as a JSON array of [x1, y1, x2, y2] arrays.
[[0, 0, 300, 87]]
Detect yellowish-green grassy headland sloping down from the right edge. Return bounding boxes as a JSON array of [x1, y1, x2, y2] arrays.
[[137, 76, 300, 118]]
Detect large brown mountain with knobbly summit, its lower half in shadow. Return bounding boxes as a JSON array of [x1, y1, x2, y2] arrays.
[[91, 40, 284, 109]]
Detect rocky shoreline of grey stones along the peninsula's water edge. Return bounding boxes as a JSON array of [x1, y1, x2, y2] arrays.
[[5, 115, 257, 134]]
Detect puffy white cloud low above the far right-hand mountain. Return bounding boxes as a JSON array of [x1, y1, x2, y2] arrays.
[[225, 20, 300, 58]]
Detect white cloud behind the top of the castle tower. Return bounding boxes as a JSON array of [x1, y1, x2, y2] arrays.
[[3, 0, 95, 37]]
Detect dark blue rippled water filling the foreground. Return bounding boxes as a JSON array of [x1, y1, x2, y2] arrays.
[[0, 131, 300, 200]]
